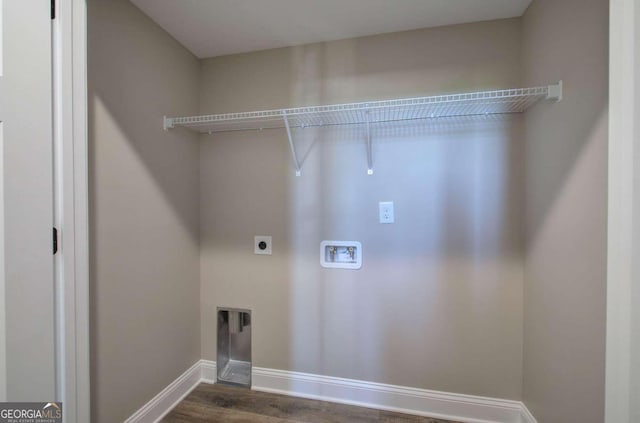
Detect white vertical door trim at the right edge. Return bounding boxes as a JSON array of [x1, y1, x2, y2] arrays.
[[605, 0, 640, 423]]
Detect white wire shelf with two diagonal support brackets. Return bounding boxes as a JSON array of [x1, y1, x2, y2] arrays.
[[163, 81, 563, 176]]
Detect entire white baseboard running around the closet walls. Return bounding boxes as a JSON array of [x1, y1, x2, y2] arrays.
[[125, 360, 537, 423]]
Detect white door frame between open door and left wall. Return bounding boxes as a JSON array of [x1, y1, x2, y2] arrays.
[[52, 0, 91, 423]]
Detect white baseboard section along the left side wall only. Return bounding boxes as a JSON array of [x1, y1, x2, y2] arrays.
[[124, 361, 202, 423]]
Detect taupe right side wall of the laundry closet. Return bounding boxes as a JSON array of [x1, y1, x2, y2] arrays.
[[522, 0, 608, 423]]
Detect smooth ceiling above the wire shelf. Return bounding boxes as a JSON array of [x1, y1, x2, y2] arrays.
[[131, 0, 531, 58]]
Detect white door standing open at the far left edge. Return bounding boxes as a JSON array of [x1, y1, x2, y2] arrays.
[[0, 0, 56, 402]]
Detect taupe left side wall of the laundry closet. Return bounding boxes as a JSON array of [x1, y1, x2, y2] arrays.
[[88, 0, 200, 423]]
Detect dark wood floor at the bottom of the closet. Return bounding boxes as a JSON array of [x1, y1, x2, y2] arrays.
[[162, 383, 455, 423]]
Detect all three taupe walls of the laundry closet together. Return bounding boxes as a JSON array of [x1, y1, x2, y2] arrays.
[[89, 0, 608, 423]]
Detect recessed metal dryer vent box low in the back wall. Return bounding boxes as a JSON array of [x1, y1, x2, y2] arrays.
[[216, 307, 251, 388]]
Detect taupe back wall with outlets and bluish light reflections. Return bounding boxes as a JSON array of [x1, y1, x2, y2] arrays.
[[200, 19, 524, 399]]
